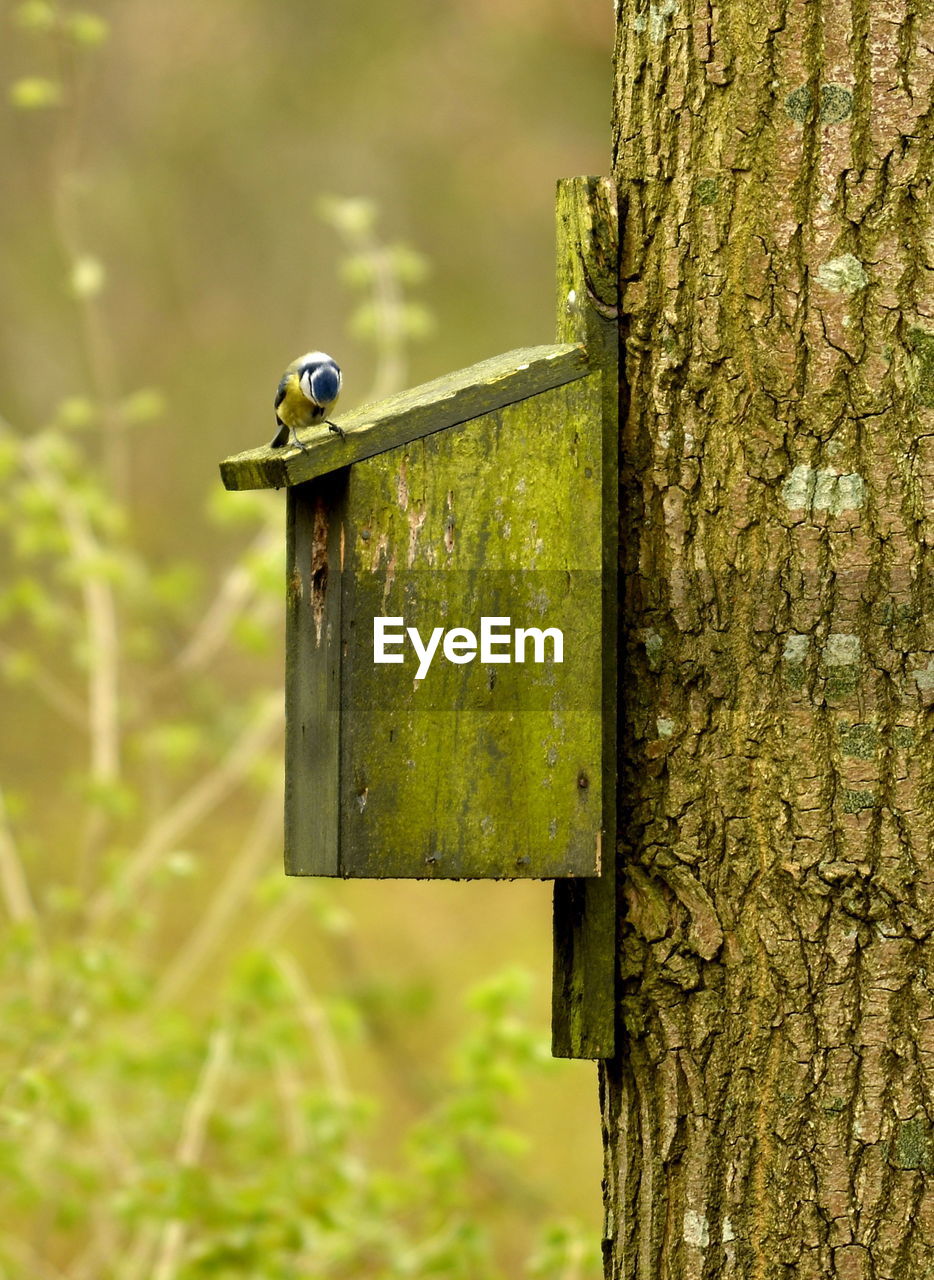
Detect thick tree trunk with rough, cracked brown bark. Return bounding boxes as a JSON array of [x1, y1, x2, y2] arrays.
[[603, 0, 934, 1280]]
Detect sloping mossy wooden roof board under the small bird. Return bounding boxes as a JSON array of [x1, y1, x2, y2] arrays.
[[220, 342, 589, 489]]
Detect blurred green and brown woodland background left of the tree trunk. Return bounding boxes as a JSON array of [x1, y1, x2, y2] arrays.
[[0, 0, 613, 1280]]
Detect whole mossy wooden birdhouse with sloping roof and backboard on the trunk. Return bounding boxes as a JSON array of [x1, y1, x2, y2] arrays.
[[214, 179, 618, 1056]]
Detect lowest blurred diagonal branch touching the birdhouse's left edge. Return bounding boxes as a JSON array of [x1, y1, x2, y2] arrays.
[[154, 791, 281, 1005]]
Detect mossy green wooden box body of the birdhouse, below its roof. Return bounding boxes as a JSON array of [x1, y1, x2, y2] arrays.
[[285, 372, 603, 878]]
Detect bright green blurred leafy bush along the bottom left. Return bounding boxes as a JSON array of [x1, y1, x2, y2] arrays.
[[0, 911, 583, 1280]]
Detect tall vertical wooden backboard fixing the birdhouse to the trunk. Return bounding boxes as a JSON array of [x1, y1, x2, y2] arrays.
[[551, 178, 619, 1059]]
